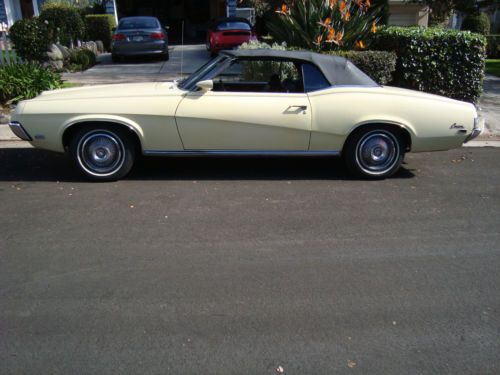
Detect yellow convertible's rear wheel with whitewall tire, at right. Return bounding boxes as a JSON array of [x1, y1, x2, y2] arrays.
[[343, 128, 404, 179]]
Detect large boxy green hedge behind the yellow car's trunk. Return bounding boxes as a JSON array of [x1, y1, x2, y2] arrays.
[[372, 27, 486, 102]]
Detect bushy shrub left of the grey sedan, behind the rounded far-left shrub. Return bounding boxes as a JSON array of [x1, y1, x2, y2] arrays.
[[40, 3, 85, 46]]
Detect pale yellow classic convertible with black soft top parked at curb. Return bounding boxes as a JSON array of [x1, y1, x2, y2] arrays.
[[10, 49, 483, 181]]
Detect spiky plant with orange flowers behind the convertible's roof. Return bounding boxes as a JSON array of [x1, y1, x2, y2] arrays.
[[268, 0, 382, 51]]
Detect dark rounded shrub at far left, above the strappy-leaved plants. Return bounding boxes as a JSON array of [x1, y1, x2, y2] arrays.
[[9, 18, 50, 62]]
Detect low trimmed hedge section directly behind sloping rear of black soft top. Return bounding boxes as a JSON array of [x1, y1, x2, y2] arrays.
[[324, 51, 397, 85]]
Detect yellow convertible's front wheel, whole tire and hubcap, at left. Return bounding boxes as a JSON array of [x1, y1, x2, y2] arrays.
[[70, 126, 135, 181]]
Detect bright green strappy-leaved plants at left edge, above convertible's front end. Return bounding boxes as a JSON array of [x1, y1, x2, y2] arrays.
[[0, 63, 62, 103]]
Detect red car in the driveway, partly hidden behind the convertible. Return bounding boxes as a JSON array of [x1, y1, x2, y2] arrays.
[[207, 17, 257, 55]]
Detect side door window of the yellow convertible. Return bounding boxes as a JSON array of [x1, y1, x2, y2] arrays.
[[213, 60, 304, 93]]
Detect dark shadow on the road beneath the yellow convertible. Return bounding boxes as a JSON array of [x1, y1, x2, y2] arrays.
[[0, 148, 414, 182]]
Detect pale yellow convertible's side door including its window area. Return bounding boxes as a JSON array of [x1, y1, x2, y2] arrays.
[[176, 61, 311, 151]]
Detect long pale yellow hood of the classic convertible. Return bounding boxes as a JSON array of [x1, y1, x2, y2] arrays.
[[33, 82, 185, 100]]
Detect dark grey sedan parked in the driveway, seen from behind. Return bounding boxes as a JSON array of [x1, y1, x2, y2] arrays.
[[111, 17, 169, 62]]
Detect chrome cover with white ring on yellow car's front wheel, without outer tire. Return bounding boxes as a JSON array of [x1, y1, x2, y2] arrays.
[[77, 130, 125, 177]]
